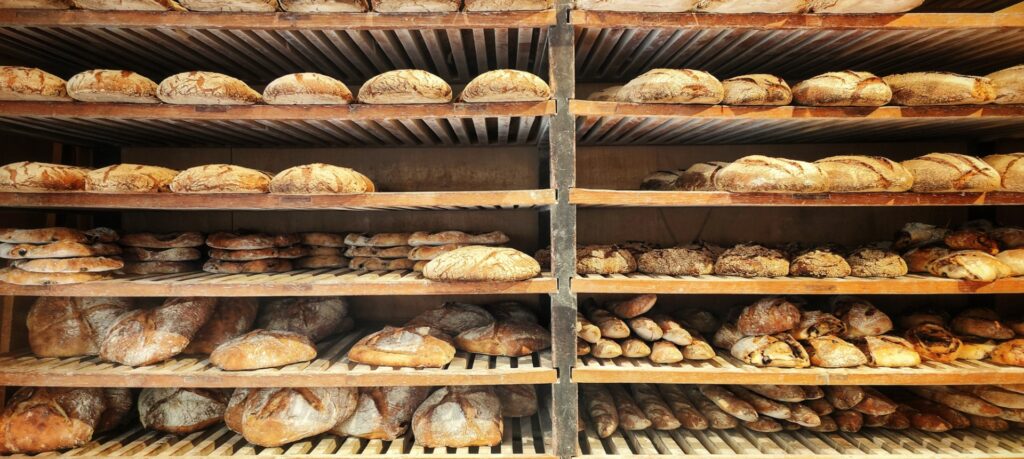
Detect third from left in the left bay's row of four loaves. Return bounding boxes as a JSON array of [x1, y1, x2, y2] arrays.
[[171, 164, 270, 193]]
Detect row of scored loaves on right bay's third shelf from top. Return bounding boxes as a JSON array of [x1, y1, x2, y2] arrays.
[[640, 153, 1024, 194]]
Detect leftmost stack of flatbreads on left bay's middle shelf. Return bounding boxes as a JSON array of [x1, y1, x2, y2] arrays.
[[0, 227, 124, 285]]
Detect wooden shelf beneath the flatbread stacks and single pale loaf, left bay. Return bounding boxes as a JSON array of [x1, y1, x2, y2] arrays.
[[0, 268, 557, 297]]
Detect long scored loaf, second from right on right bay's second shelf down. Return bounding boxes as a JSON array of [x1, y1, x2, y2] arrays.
[[883, 72, 995, 106]]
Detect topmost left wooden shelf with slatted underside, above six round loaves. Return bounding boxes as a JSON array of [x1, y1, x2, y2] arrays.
[[0, 9, 555, 84]]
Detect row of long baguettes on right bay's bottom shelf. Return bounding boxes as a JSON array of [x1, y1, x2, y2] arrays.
[[580, 383, 1024, 439]]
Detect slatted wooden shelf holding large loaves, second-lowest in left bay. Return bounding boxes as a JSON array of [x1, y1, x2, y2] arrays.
[[0, 327, 556, 387]]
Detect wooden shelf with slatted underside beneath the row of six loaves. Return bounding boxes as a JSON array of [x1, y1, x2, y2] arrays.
[[0, 100, 555, 147]]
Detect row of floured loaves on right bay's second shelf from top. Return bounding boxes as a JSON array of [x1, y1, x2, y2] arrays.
[[588, 66, 1024, 107]]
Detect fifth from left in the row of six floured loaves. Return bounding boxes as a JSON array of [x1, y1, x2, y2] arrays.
[[359, 69, 459, 105]]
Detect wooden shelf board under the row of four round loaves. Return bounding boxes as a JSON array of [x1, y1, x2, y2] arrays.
[[0, 190, 555, 210]]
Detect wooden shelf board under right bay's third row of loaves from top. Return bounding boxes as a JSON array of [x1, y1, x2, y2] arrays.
[[573, 189, 1024, 207]]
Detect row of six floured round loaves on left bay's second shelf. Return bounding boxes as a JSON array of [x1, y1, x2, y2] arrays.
[[0, 67, 551, 106]]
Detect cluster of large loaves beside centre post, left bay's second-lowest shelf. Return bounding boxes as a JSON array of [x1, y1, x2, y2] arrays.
[[348, 302, 551, 368]]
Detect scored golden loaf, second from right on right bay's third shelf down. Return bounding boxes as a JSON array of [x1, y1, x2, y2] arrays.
[[902, 153, 999, 193]]
